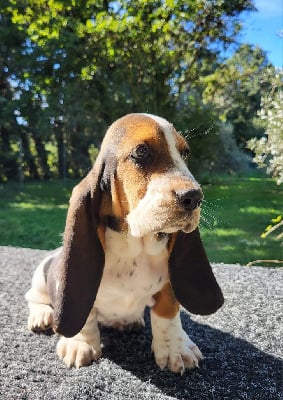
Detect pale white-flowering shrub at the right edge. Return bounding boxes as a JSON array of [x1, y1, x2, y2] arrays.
[[248, 70, 283, 185]]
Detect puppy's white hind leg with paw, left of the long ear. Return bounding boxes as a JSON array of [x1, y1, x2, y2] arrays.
[[25, 254, 56, 332]]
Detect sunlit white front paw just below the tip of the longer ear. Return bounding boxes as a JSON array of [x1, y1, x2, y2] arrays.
[[56, 337, 101, 368]]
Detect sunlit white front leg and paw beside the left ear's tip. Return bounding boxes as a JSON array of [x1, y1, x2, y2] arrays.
[[57, 308, 101, 368]]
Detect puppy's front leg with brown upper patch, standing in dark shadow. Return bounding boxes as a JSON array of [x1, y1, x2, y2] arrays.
[[151, 283, 203, 374]]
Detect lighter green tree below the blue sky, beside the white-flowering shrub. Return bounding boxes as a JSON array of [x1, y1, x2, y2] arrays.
[[201, 44, 271, 147]]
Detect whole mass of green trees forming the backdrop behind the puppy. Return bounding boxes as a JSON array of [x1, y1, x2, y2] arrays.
[[0, 0, 272, 182]]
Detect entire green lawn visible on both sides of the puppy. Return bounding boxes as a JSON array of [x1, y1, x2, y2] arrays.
[[0, 177, 282, 266]]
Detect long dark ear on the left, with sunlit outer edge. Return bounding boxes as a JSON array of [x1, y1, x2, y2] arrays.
[[51, 160, 104, 337]]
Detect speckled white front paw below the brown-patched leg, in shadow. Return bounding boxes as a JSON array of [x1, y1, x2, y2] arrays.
[[152, 331, 203, 375]]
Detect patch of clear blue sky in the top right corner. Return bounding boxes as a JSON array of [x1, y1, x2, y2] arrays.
[[240, 0, 283, 68]]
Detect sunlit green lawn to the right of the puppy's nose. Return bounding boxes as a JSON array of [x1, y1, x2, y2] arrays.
[[201, 177, 283, 266]]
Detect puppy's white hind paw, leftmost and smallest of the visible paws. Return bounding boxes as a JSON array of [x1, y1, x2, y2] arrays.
[[28, 303, 53, 332]]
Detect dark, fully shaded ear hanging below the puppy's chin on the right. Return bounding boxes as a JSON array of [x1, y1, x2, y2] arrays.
[[169, 228, 224, 315]]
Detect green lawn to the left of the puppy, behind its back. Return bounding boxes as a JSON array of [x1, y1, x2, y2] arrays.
[[0, 181, 76, 249]]
